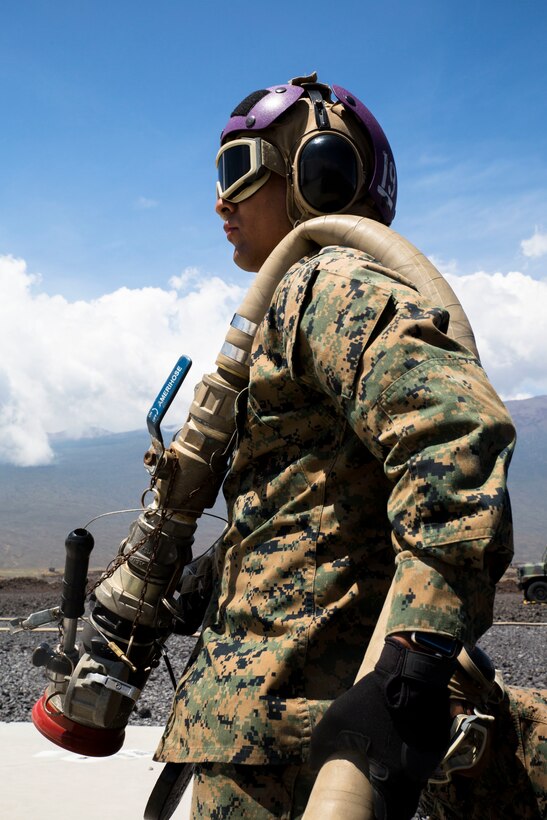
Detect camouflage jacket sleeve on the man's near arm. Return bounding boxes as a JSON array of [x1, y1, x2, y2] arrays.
[[290, 253, 515, 644]]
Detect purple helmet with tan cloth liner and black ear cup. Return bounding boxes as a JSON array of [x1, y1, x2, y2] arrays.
[[217, 74, 397, 225]]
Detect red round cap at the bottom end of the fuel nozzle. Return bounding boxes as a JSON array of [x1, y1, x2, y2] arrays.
[[32, 695, 125, 757]]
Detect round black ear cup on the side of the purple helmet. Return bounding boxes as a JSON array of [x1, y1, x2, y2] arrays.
[[295, 131, 364, 214]]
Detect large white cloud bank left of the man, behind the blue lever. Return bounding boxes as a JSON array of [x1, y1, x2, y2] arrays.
[[0, 256, 244, 466]]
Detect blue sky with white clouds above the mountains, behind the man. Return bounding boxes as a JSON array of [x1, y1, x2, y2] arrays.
[[0, 0, 547, 462]]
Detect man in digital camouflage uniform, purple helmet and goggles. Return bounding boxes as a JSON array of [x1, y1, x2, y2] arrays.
[[153, 76, 524, 818]]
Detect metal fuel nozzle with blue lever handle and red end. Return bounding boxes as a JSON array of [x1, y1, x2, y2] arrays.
[[27, 357, 243, 756]]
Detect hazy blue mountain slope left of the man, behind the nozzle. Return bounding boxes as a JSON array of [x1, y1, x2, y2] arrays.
[[0, 431, 225, 570]]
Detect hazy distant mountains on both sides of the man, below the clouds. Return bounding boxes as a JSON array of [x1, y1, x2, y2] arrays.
[[0, 396, 547, 570]]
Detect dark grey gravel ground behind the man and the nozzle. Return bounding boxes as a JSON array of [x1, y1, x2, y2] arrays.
[[0, 578, 547, 726]]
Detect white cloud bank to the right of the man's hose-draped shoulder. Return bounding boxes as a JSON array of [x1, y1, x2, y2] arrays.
[[441, 267, 547, 399]]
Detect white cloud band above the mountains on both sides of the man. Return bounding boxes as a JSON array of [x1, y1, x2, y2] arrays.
[[0, 250, 547, 465]]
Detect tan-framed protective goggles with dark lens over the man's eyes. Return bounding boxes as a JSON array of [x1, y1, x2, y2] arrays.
[[216, 137, 286, 202]]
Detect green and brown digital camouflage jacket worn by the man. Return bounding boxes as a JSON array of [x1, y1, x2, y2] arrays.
[[157, 247, 514, 764]]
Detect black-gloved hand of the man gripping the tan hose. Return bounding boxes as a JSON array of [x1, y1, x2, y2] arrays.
[[311, 638, 456, 820]]
